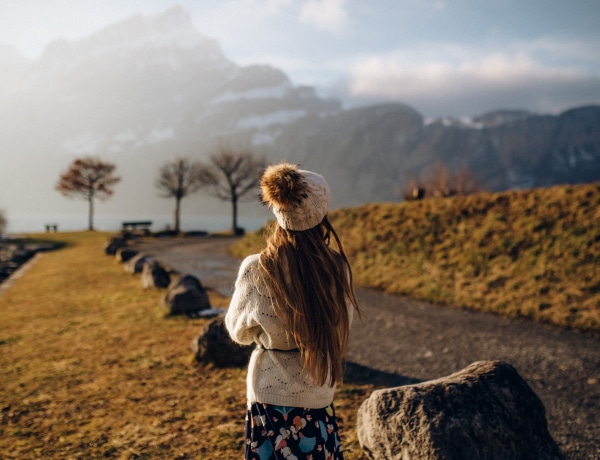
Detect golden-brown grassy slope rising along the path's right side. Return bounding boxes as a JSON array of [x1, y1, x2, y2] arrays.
[[235, 183, 600, 330]]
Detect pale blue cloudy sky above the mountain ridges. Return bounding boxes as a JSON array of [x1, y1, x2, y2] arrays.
[[0, 0, 600, 116]]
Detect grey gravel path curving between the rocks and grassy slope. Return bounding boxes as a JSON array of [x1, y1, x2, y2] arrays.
[[134, 238, 600, 460]]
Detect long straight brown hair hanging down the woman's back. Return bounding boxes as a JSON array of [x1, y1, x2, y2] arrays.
[[260, 216, 360, 386]]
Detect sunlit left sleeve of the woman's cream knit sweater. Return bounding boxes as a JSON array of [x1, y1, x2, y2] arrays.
[[225, 254, 261, 345]]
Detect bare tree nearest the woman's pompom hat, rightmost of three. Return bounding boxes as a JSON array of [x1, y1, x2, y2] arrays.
[[203, 147, 266, 235]]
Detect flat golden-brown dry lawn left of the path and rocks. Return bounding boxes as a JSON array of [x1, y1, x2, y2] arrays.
[[0, 233, 372, 460]]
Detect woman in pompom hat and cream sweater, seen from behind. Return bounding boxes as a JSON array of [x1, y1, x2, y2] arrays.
[[225, 163, 359, 460]]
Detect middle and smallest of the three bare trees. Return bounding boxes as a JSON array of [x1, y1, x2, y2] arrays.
[[155, 158, 204, 233]]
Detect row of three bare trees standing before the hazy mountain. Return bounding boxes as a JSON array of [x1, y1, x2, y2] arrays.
[[56, 147, 266, 234]]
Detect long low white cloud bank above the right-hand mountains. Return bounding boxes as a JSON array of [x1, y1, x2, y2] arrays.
[[346, 44, 600, 115]]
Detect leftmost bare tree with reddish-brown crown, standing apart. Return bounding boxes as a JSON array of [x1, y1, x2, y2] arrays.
[[56, 157, 121, 230]]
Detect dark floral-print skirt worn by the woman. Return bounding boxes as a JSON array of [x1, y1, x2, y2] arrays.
[[245, 403, 344, 460]]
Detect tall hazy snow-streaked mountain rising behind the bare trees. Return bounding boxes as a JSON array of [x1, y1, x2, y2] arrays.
[[0, 7, 341, 220]]
